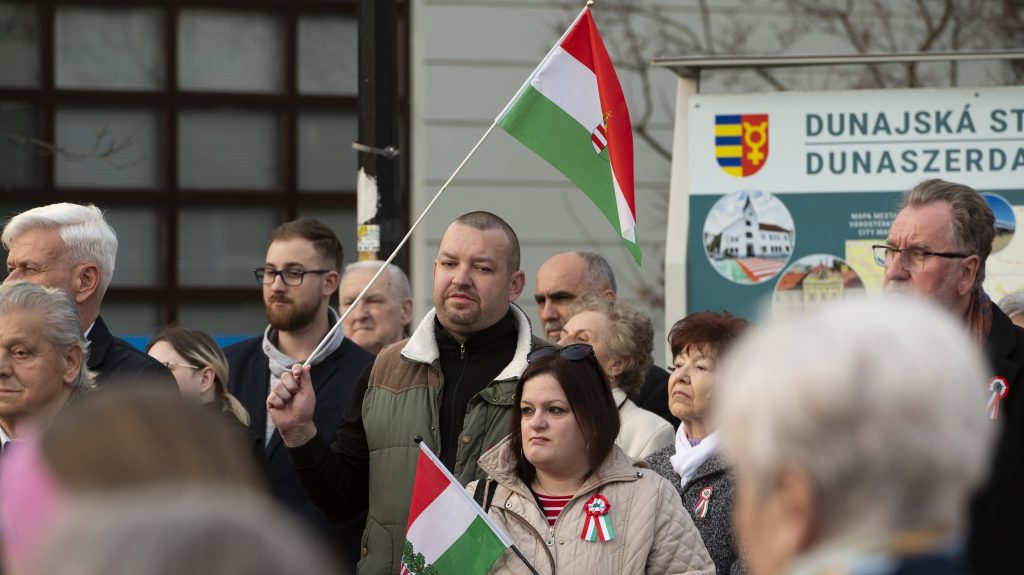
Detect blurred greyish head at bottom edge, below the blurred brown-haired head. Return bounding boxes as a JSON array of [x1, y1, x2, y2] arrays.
[[34, 487, 338, 575]]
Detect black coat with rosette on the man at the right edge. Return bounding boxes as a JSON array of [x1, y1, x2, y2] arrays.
[[968, 306, 1024, 574]]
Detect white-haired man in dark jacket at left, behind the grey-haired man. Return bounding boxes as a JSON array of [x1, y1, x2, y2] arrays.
[[0, 204, 177, 387]]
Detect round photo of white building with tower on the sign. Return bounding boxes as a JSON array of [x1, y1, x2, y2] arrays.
[[703, 191, 796, 284]]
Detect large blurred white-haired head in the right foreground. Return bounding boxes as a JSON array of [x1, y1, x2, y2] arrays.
[[717, 298, 991, 575]]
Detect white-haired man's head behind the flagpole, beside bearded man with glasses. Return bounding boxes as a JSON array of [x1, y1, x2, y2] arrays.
[[338, 261, 413, 355]]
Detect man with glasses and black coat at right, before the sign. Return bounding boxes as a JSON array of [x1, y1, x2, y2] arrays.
[[873, 179, 1024, 574]]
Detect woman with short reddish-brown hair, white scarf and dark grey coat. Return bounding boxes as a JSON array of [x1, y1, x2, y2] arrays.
[[647, 312, 750, 575]]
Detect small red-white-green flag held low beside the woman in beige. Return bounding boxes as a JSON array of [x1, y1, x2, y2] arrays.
[[401, 441, 512, 575]]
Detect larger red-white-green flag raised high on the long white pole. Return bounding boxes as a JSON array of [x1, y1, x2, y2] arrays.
[[496, 8, 642, 264]]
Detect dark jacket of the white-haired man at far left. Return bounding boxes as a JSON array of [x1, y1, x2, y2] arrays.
[[86, 317, 178, 389]]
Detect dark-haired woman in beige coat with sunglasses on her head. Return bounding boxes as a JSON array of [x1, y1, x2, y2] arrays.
[[467, 344, 714, 575]]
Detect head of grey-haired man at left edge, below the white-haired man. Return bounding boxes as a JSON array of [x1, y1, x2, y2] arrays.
[[0, 281, 92, 453]]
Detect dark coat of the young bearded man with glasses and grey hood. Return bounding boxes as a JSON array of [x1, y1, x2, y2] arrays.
[[224, 336, 374, 573]]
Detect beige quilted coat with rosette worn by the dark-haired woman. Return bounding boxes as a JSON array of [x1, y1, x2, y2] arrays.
[[468, 438, 715, 575]]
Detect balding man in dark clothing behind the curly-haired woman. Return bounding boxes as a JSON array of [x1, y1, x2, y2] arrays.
[[534, 251, 679, 428]]
